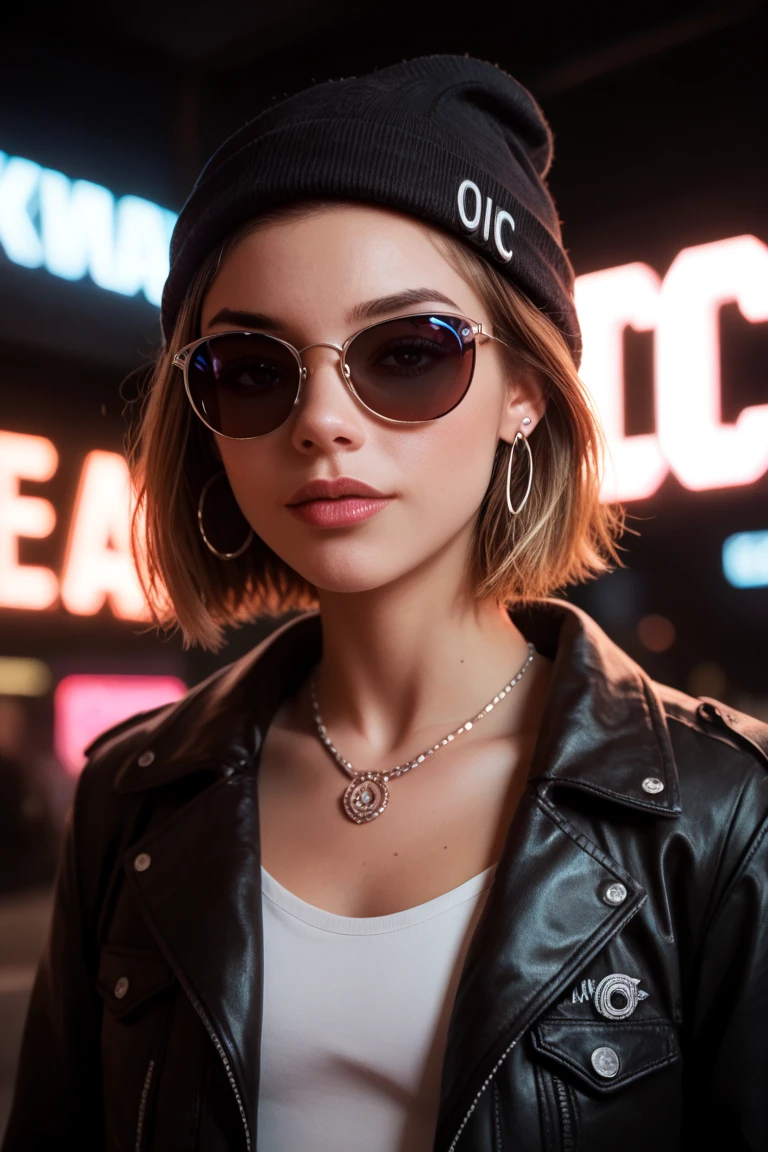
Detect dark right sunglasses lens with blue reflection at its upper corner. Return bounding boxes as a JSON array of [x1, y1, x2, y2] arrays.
[[347, 314, 474, 420]]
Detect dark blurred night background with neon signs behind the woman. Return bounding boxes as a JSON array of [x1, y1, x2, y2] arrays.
[[0, 0, 768, 1134]]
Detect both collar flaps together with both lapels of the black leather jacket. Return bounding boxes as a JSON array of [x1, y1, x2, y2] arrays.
[[88, 599, 680, 1152]]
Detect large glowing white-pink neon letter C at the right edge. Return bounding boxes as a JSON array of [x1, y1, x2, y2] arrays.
[[656, 236, 768, 491]]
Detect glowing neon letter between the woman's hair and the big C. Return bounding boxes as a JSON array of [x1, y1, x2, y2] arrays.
[[576, 263, 668, 501]]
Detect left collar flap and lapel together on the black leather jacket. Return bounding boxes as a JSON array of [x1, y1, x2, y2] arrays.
[[103, 613, 321, 1150]]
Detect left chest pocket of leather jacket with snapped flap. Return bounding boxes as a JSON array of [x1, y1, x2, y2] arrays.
[[97, 943, 175, 1152]]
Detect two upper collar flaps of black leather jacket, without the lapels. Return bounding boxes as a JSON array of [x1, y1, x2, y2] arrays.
[[105, 598, 680, 816]]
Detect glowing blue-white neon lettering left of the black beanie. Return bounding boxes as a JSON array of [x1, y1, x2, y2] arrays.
[[0, 152, 176, 306]]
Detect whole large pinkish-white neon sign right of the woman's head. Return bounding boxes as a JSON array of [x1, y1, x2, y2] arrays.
[[576, 236, 768, 500]]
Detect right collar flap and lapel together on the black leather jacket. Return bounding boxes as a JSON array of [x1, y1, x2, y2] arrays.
[[435, 601, 680, 1152]]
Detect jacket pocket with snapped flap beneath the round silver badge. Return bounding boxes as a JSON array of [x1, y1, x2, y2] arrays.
[[531, 1017, 682, 1152]]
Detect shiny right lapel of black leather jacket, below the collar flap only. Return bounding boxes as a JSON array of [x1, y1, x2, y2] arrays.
[[434, 786, 647, 1152]]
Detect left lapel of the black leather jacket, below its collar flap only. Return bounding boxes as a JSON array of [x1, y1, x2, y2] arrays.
[[123, 772, 263, 1149]]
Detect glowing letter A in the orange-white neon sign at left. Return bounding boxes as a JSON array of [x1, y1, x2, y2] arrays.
[[61, 452, 147, 620]]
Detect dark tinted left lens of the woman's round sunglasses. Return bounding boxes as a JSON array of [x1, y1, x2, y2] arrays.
[[187, 332, 301, 439]]
